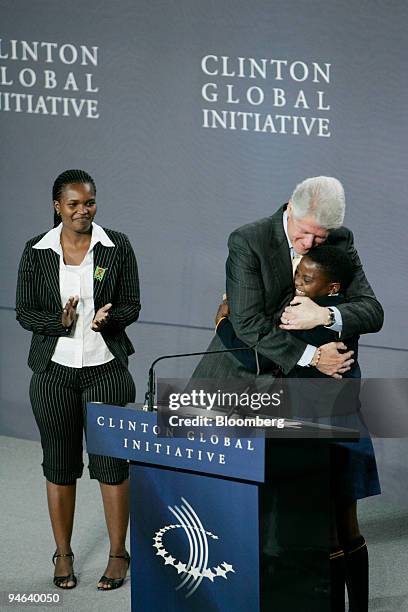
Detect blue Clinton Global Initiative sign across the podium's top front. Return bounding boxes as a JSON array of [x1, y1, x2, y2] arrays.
[[87, 402, 265, 482]]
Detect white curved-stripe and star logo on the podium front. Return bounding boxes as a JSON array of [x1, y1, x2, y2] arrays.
[[153, 497, 235, 599]]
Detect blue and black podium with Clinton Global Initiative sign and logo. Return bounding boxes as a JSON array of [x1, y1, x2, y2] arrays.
[[87, 403, 356, 612]]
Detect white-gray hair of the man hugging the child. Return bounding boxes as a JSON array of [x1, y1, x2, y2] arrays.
[[290, 176, 346, 229]]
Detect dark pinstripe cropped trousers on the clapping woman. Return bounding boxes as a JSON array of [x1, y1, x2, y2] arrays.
[[30, 359, 136, 484]]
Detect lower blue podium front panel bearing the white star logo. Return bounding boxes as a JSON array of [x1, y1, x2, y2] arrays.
[[130, 464, 259, 612]]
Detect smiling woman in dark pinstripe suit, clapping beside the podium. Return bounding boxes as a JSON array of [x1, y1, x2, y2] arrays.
[[16, 170, 140, 590]]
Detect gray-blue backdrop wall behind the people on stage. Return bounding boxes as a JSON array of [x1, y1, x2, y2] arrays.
[[0, 0, 408, 437]]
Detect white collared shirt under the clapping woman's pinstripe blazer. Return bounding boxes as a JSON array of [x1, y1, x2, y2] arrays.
[[33, 223, 115, 368]]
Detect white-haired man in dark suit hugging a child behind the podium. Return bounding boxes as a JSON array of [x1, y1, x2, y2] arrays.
[[194, 177, 383, 378]]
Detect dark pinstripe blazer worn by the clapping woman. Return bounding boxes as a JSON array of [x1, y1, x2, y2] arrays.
[[16, 228, 140, 372]]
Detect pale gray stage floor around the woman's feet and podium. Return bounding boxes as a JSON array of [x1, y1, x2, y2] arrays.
[[0, 436, 408, 612]]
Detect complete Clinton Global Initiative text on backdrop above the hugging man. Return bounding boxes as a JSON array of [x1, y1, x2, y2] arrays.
[[201, 54, 332, 138]]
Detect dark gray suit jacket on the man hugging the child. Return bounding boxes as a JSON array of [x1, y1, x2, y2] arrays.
[[193, 205, 384, 378]]
